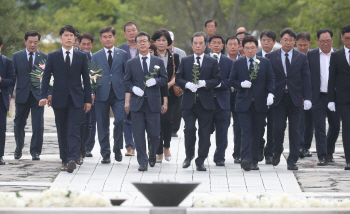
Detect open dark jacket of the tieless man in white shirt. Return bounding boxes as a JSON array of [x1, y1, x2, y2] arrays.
[[306, 48, 337, 103]]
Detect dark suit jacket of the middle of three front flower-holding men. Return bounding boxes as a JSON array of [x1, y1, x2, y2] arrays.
[[175, 54, 221, 110]]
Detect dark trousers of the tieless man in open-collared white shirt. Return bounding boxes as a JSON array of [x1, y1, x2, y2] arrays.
[[312, 93, 340, 159]]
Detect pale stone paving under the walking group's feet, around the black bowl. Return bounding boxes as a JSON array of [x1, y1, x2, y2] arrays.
[[0, 104, 350, 207]]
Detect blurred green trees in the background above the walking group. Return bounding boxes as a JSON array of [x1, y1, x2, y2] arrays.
[[0, 0, 350, 57]]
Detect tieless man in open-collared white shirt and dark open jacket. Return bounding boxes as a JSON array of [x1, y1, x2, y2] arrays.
[[305, 29, 340, 166]]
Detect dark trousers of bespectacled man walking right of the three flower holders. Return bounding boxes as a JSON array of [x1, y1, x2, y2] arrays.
[[273, 93, 301, 164]]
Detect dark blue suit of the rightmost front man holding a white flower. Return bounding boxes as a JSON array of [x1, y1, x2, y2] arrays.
[[229, 56, 275, 164]]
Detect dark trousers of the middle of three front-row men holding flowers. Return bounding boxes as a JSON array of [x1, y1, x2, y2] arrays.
[[182, 100, 214, 166]]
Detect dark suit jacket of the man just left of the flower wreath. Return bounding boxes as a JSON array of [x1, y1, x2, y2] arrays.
[[11, 49, 47, 103]]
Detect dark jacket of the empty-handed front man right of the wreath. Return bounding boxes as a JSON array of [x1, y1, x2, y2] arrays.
[[41, 48, 91, 108]]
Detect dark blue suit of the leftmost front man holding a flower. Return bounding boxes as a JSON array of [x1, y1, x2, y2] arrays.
[[124, 55, 168, 165]]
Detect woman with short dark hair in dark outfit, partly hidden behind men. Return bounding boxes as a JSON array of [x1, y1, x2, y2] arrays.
[[151, 29, 180, 163]]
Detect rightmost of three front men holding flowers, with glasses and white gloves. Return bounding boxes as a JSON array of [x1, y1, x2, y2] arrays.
[[229, 36, 275, 171]]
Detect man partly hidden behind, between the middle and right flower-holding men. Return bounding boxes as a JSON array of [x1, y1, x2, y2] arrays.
[[209, 34, 233, 166]]
